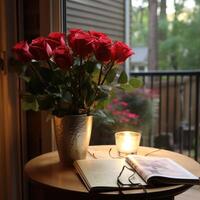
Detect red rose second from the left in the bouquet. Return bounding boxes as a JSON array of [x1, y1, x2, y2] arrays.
[[29, 37, 52, 60]]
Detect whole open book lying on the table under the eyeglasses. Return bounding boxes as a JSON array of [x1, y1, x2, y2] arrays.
[[74, 156, 200, 191]]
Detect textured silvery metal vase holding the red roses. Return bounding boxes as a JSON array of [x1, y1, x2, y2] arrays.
[[54, 115, 93, 166]]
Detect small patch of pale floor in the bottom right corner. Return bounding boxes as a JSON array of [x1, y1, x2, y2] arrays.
[[175, 186, 200, 200]]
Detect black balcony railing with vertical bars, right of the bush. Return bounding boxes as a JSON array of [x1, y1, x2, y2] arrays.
[[131, 71, 200, 160]]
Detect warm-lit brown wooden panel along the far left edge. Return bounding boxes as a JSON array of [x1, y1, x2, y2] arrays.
[[0, 0, 23, 200]]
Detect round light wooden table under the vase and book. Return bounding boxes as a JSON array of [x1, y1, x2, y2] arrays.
[[25, 145, 200, 200]]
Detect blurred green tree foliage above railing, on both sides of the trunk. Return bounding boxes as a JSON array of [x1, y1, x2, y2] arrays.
[[132, 0, 200, 69]]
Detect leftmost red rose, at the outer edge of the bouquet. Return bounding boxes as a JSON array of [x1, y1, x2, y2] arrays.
[[13, 41, 32, 62]]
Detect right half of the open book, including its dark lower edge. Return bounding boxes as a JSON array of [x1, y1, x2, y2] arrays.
[[126, 155, 200, 185]]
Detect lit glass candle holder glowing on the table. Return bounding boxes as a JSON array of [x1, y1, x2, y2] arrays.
[[115, 131, 141, 154]]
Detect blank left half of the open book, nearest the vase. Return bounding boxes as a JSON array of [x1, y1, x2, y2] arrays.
[[74, 159, 146, 192]]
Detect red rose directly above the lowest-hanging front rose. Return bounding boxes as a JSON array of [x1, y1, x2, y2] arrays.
[[46, 32, 65, 50]]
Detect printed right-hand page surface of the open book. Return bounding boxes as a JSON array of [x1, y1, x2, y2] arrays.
[[126, 155, 198, 182]]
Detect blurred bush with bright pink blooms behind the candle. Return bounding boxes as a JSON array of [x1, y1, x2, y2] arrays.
[[92, 89, 153, 144]]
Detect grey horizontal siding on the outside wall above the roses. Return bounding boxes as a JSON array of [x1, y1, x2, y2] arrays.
[[66, 0, 125, 41]]
